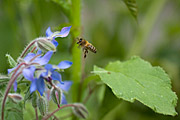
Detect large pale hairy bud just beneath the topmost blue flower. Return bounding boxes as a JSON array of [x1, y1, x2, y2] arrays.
[[36, 37, 56, 52]]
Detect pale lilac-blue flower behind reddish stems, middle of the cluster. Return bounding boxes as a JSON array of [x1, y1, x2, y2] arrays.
[[8, 51, 53, 91]]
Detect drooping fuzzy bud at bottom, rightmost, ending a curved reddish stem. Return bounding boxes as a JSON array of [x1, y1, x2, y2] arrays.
[[72, 103, 88, 119]]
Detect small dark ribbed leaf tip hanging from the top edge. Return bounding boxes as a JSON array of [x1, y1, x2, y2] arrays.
[[123, 0, 138, 20]]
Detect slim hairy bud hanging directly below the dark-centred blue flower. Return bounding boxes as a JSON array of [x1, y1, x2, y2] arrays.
[[50, 87, 61, 107]]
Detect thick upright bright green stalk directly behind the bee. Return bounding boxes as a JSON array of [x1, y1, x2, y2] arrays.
[[70, 0, 82, 102]]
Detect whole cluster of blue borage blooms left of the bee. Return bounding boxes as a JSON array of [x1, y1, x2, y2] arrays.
[[8, 26, 72, 104]]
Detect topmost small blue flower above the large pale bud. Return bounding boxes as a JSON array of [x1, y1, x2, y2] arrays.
[[46, 26, 71, 47]]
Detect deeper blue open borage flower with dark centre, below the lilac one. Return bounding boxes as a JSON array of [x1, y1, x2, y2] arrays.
[[23, 61, 72, 96]]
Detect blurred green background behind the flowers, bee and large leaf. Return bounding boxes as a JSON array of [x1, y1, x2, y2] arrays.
[[0, 0, 180, 120]]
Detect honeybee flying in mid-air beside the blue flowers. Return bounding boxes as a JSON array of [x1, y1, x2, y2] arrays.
[[77, 38, 97, 58]]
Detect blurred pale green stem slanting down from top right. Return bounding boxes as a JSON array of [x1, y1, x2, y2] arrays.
[[128, 0, 167, 57]]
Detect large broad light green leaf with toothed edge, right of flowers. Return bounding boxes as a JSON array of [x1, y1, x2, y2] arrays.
[[94, 57, 177, 116]]
